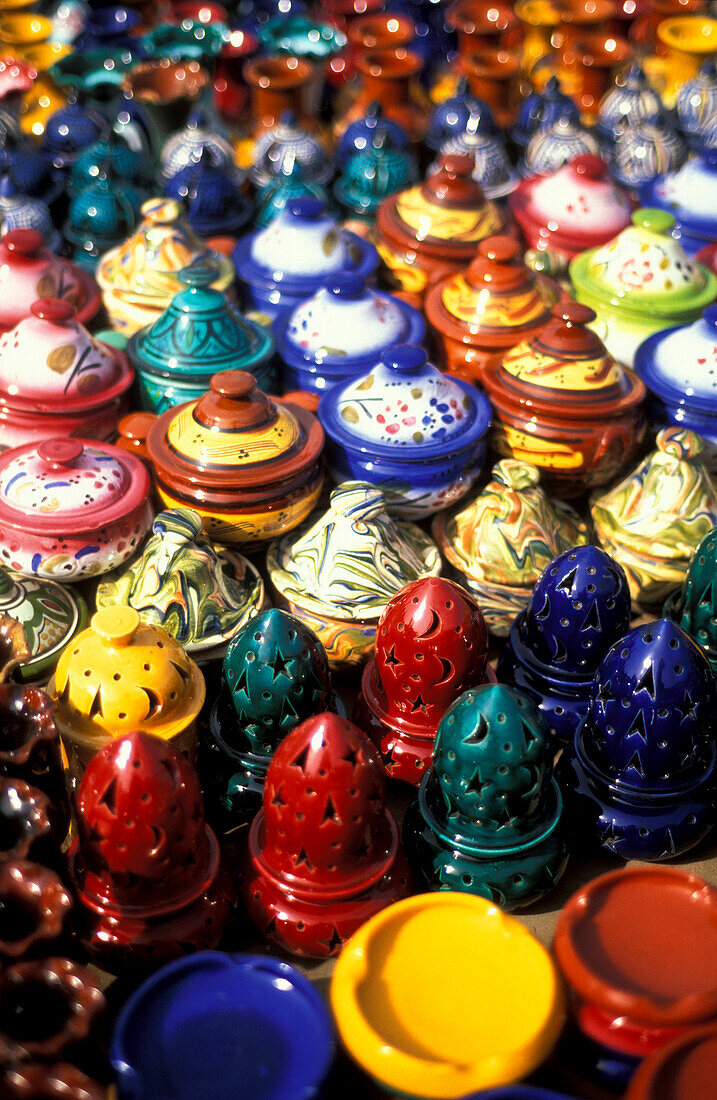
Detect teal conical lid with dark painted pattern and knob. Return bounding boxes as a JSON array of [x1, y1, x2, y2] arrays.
[[128, 260, 275, 378]]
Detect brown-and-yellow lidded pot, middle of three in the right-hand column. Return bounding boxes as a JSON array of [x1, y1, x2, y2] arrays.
[[424, 237, 562, 382]]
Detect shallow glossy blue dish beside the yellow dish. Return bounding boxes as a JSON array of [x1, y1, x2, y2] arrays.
[[112, 952, 334, 1100]]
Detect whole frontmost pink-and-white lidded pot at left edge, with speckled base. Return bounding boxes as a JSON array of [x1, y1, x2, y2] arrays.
[[0, 438, 152, 581]]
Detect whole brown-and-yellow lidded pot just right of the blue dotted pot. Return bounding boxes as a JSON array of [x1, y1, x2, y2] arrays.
[[483, 301, 646, 497]]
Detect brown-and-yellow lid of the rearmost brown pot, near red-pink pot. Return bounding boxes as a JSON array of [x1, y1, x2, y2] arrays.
[[376, 154, 504, 261]]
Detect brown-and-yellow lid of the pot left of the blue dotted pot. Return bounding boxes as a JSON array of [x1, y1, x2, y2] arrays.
[[146, 371, 323, 494]]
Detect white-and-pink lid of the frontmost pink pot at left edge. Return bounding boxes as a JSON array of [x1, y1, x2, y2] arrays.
[[0, 438, 150, 536]]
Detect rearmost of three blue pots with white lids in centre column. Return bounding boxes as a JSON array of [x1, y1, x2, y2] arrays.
[[233, 198, 378, 317]]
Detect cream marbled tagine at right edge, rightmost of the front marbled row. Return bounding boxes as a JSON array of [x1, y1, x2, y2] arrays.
[[591, 427, 717, 606]]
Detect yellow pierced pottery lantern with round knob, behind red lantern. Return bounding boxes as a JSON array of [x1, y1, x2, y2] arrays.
[[47, 606, 205, 782]]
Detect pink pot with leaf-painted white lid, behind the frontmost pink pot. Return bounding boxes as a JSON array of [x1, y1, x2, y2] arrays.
[[0, 298, 134, 449]]
